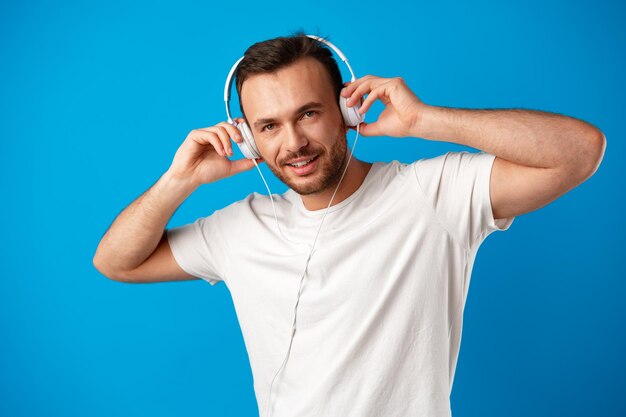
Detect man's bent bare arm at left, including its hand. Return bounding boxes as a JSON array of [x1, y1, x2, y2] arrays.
[[93, 122, 263, 283]]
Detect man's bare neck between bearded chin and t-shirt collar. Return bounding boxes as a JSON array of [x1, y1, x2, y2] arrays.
[[300, 158, 372, 211]]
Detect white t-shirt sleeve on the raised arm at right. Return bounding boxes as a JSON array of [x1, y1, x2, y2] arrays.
[[413, 151, 515, 249]]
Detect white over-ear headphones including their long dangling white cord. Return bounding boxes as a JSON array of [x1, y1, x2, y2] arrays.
[[224, 35, 365, 415]]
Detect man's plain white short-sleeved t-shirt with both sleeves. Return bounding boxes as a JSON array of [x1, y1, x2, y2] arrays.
[[168, 151, 514, 417]]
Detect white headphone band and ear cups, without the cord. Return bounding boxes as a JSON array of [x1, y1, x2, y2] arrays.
[[224, 35, 363, 159]]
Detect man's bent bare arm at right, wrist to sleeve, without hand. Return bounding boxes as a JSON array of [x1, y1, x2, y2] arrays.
[[414, 106, 606, 219]]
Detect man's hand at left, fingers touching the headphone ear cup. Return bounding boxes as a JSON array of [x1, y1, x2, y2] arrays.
[[168, 119, 264, 187]]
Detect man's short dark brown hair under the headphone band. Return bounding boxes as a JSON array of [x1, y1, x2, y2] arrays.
[[235, 30, 343, 121]]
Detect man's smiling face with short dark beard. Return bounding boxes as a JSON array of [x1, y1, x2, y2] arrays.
[[241, 58, 347, 195]]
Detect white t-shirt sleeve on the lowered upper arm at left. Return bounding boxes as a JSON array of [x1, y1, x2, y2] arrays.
[[167, 210, 228, 285]]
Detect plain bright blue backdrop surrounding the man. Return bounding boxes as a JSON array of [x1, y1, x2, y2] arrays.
[[0, 0, 626, 417]]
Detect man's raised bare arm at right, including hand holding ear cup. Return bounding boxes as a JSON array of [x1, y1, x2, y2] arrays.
[[341, 75, 606, 219]]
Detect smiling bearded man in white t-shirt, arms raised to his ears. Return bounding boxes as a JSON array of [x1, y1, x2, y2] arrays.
[[94, 34, 606, 417]]
